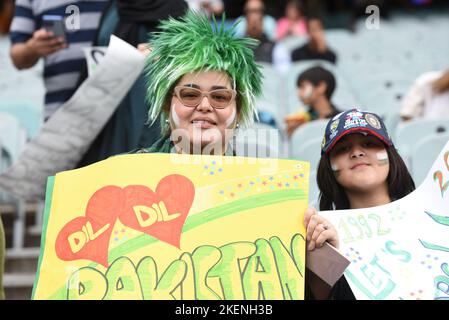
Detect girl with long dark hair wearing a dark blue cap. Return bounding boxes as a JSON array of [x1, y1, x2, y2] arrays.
[[304, 109, 415, 299]]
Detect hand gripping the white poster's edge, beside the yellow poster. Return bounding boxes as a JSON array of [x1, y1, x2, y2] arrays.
[[304, 207, 339, 251]]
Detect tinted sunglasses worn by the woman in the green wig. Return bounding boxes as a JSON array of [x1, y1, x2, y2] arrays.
[[175, 86, 237, 109]]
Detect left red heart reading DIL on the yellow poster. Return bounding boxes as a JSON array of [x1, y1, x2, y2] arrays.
[[55, 186, 125, 267]]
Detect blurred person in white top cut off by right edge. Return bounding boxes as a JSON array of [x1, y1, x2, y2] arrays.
[[400, 71, 449, 121]]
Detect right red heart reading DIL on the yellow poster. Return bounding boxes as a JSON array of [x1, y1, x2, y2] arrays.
[[119, 174, 195, 248]]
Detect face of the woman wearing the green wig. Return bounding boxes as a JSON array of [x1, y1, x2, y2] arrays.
[[170, 71, 238, 154]]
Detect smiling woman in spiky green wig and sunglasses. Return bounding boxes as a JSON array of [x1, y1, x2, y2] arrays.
[[136, 12, 346, 299]]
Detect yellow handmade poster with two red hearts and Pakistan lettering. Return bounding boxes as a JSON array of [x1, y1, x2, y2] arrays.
[[33, 154, 309, 300]]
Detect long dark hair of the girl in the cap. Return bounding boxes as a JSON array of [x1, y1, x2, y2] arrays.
[[317, 146, 415, 210]]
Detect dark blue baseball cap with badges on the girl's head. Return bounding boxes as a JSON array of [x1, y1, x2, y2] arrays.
[[321, 109, 393, 155]]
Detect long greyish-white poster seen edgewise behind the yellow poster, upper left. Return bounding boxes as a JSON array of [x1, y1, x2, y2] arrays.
[[0, 36, 145, 200]]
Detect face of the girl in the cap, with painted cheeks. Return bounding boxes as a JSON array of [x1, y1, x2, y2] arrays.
[[329, 133, 390, 193]]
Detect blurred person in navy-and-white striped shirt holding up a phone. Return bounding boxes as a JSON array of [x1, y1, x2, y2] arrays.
[[10, 0, 109, 120]]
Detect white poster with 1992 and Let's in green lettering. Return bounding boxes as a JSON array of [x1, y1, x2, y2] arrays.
[[320, 143, 449, 300]]
